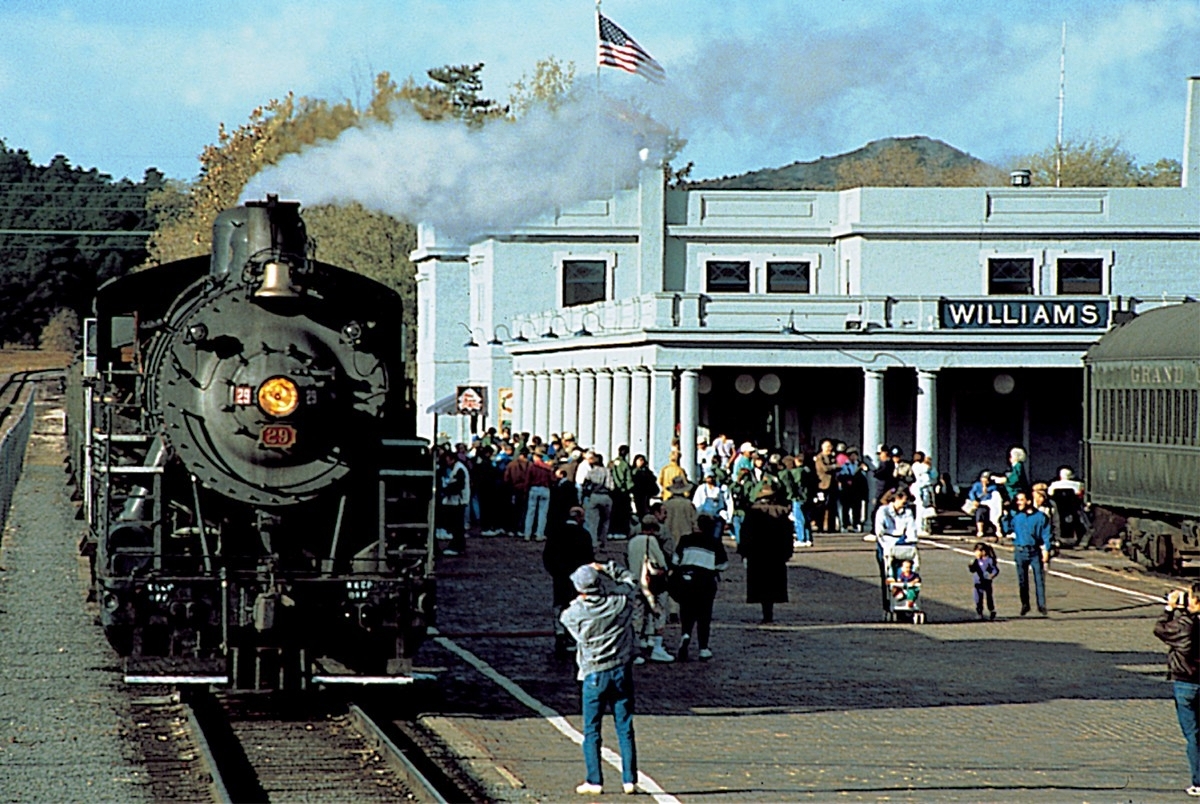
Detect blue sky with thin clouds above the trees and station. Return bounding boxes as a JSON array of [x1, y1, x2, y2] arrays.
[[0, 0, 1200, 179]]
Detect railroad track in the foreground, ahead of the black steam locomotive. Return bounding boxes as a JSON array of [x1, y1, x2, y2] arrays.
[[136, 692, 486, 802]]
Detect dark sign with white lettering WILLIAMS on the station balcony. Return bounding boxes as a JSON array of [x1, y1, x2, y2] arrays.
[[940, 298, 1109, 330]]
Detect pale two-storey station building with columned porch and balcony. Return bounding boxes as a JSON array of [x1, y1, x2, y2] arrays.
[[413, 78, 1200, 484]]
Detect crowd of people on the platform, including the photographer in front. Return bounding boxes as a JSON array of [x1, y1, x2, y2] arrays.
[[436, 430, 1132, 794]]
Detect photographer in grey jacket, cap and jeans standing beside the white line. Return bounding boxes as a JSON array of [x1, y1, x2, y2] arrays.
[[559, 562, 638, 796]]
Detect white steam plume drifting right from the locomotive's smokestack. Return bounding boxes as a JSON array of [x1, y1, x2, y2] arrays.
[[242, 96, 667, 242]]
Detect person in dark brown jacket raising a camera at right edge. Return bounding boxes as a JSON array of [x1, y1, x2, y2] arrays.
[[1154, 583, 1200, 797]]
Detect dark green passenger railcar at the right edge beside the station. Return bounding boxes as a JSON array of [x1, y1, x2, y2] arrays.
[[1084, 302, 1200, 572]]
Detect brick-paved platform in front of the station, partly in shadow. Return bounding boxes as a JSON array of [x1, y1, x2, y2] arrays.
[[420, 536, 1187, 802]]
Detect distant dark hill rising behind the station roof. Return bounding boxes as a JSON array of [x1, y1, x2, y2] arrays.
[[685, 137, 1004, 190]]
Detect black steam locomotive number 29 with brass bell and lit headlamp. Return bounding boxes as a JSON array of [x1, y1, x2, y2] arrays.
[[72, 197, 434, 690]]
